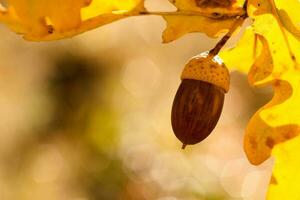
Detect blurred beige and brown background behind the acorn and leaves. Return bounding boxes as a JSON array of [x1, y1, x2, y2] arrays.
[[0, 0, 273, 200]]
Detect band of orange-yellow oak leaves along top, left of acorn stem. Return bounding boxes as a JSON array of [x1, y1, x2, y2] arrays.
[[0, 0, 244, 42]]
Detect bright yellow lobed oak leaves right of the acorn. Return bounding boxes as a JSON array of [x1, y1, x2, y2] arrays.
[[221, 0, 300, 199]]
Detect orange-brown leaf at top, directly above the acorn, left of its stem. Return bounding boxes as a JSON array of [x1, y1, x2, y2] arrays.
[[163, 0, 244, 43]]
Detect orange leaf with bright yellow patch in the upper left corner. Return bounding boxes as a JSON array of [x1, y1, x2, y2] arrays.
[[0, 0, 144, 41]]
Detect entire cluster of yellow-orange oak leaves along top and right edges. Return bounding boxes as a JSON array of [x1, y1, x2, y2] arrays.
[[0, 0, 300, 199]]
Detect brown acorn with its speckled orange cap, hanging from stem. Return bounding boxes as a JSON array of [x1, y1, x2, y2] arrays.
[[171, 52, 230, 149]]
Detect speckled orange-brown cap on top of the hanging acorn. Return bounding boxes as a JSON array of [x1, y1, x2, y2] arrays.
[[181, 52, 230, 93]]
